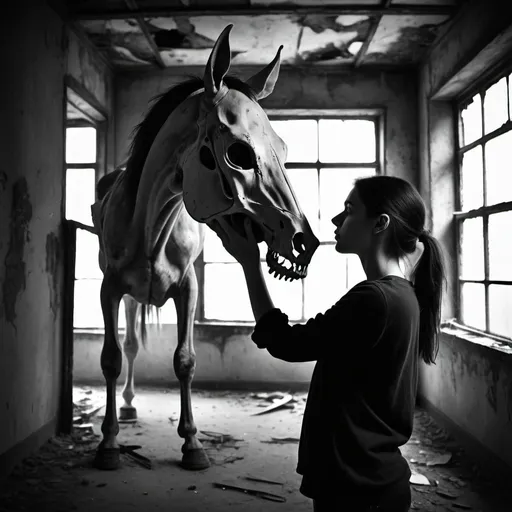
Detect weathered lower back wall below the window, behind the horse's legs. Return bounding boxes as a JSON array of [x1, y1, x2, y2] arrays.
[[73, 324, 314, 389]]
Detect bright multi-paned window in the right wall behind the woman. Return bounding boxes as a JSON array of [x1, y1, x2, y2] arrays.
[[455, 74, 512, 339]]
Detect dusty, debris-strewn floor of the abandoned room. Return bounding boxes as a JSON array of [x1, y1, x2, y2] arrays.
[[0, 387, 512, 512]]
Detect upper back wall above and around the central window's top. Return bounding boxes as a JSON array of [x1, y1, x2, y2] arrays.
[[115, 68, 417, 182]]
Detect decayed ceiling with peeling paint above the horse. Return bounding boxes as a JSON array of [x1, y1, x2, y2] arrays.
[[67, 0, 466, 70]]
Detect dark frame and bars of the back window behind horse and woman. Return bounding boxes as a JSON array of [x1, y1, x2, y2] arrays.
[[194, 108, 385, 326]]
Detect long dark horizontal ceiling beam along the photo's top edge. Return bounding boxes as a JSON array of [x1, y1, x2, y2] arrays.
[[69, 4, 457, 20]]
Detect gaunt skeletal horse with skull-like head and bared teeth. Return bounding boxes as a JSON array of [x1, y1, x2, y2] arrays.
[[91, 25, 319, 470]]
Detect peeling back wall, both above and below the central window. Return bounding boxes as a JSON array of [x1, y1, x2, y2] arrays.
[[74, 64, 417, 387]]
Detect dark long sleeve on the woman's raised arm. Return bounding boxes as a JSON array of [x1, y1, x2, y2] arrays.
[[252, 281, 387, 362]]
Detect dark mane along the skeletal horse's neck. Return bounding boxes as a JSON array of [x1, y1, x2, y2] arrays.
[[120, 75, 256, 200]]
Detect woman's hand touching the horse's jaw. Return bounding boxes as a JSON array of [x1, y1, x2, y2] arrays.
[[207, 217, 260, 269]]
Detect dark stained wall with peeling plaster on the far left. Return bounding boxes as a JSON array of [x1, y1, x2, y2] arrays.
[[0, 0, 114, 473]]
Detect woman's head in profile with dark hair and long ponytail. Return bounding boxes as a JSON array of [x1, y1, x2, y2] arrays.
[[332, 176, 445, 363]]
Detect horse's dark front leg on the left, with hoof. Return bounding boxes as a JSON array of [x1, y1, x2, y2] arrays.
[[94, 275, 123, 469]]
